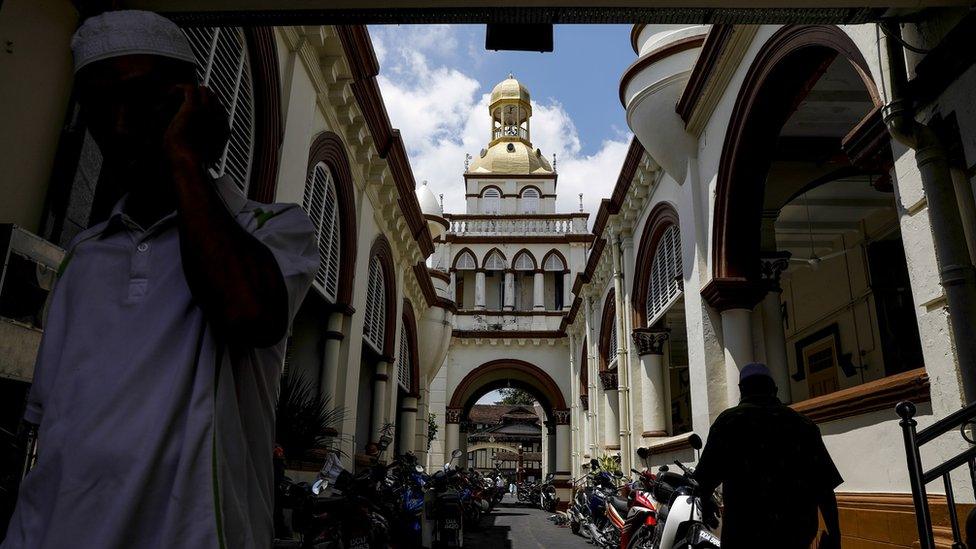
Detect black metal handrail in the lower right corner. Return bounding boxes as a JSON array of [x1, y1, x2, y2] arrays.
[[895, 401, 976, 549]]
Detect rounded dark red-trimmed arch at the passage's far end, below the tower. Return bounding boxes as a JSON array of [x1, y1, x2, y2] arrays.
[[444, 358, 571, 505]]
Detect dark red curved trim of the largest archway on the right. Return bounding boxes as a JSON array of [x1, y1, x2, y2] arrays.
[[702, 25, 880, 294]]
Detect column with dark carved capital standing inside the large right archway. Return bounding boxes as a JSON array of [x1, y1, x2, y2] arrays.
[[761, 252, 792, 404]]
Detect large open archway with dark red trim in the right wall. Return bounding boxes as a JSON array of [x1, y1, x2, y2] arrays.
[[702, 25, 922, 416]]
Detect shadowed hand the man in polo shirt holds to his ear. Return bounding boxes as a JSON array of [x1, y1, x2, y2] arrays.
[[163, 84, 230, 165]]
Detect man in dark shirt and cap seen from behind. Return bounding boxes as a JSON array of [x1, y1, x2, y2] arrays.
[[695, 363, 843, 549]]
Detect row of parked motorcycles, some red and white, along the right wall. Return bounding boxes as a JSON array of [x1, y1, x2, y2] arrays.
[[568, 435, 721, 549]]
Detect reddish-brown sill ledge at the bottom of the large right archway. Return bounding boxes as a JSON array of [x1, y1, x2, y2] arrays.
[[791, 368, 932, 423]]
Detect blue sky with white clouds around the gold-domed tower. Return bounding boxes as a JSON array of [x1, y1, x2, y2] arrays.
[[369, 25, 636, 216]]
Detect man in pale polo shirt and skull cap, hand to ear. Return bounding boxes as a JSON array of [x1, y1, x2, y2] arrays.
[[2, 11, 318, 549]]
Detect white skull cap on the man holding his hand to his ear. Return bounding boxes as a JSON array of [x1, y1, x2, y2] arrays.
[[71, 10, 197, 74]]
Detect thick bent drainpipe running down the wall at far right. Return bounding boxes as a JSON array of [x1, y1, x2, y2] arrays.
[[882, 23, 976, 404]]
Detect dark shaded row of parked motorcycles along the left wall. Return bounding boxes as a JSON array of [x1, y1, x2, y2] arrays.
[[275, 450, 506, 549]]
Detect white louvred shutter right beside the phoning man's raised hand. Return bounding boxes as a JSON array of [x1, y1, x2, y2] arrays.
[[183, 27, 254, 195]]
